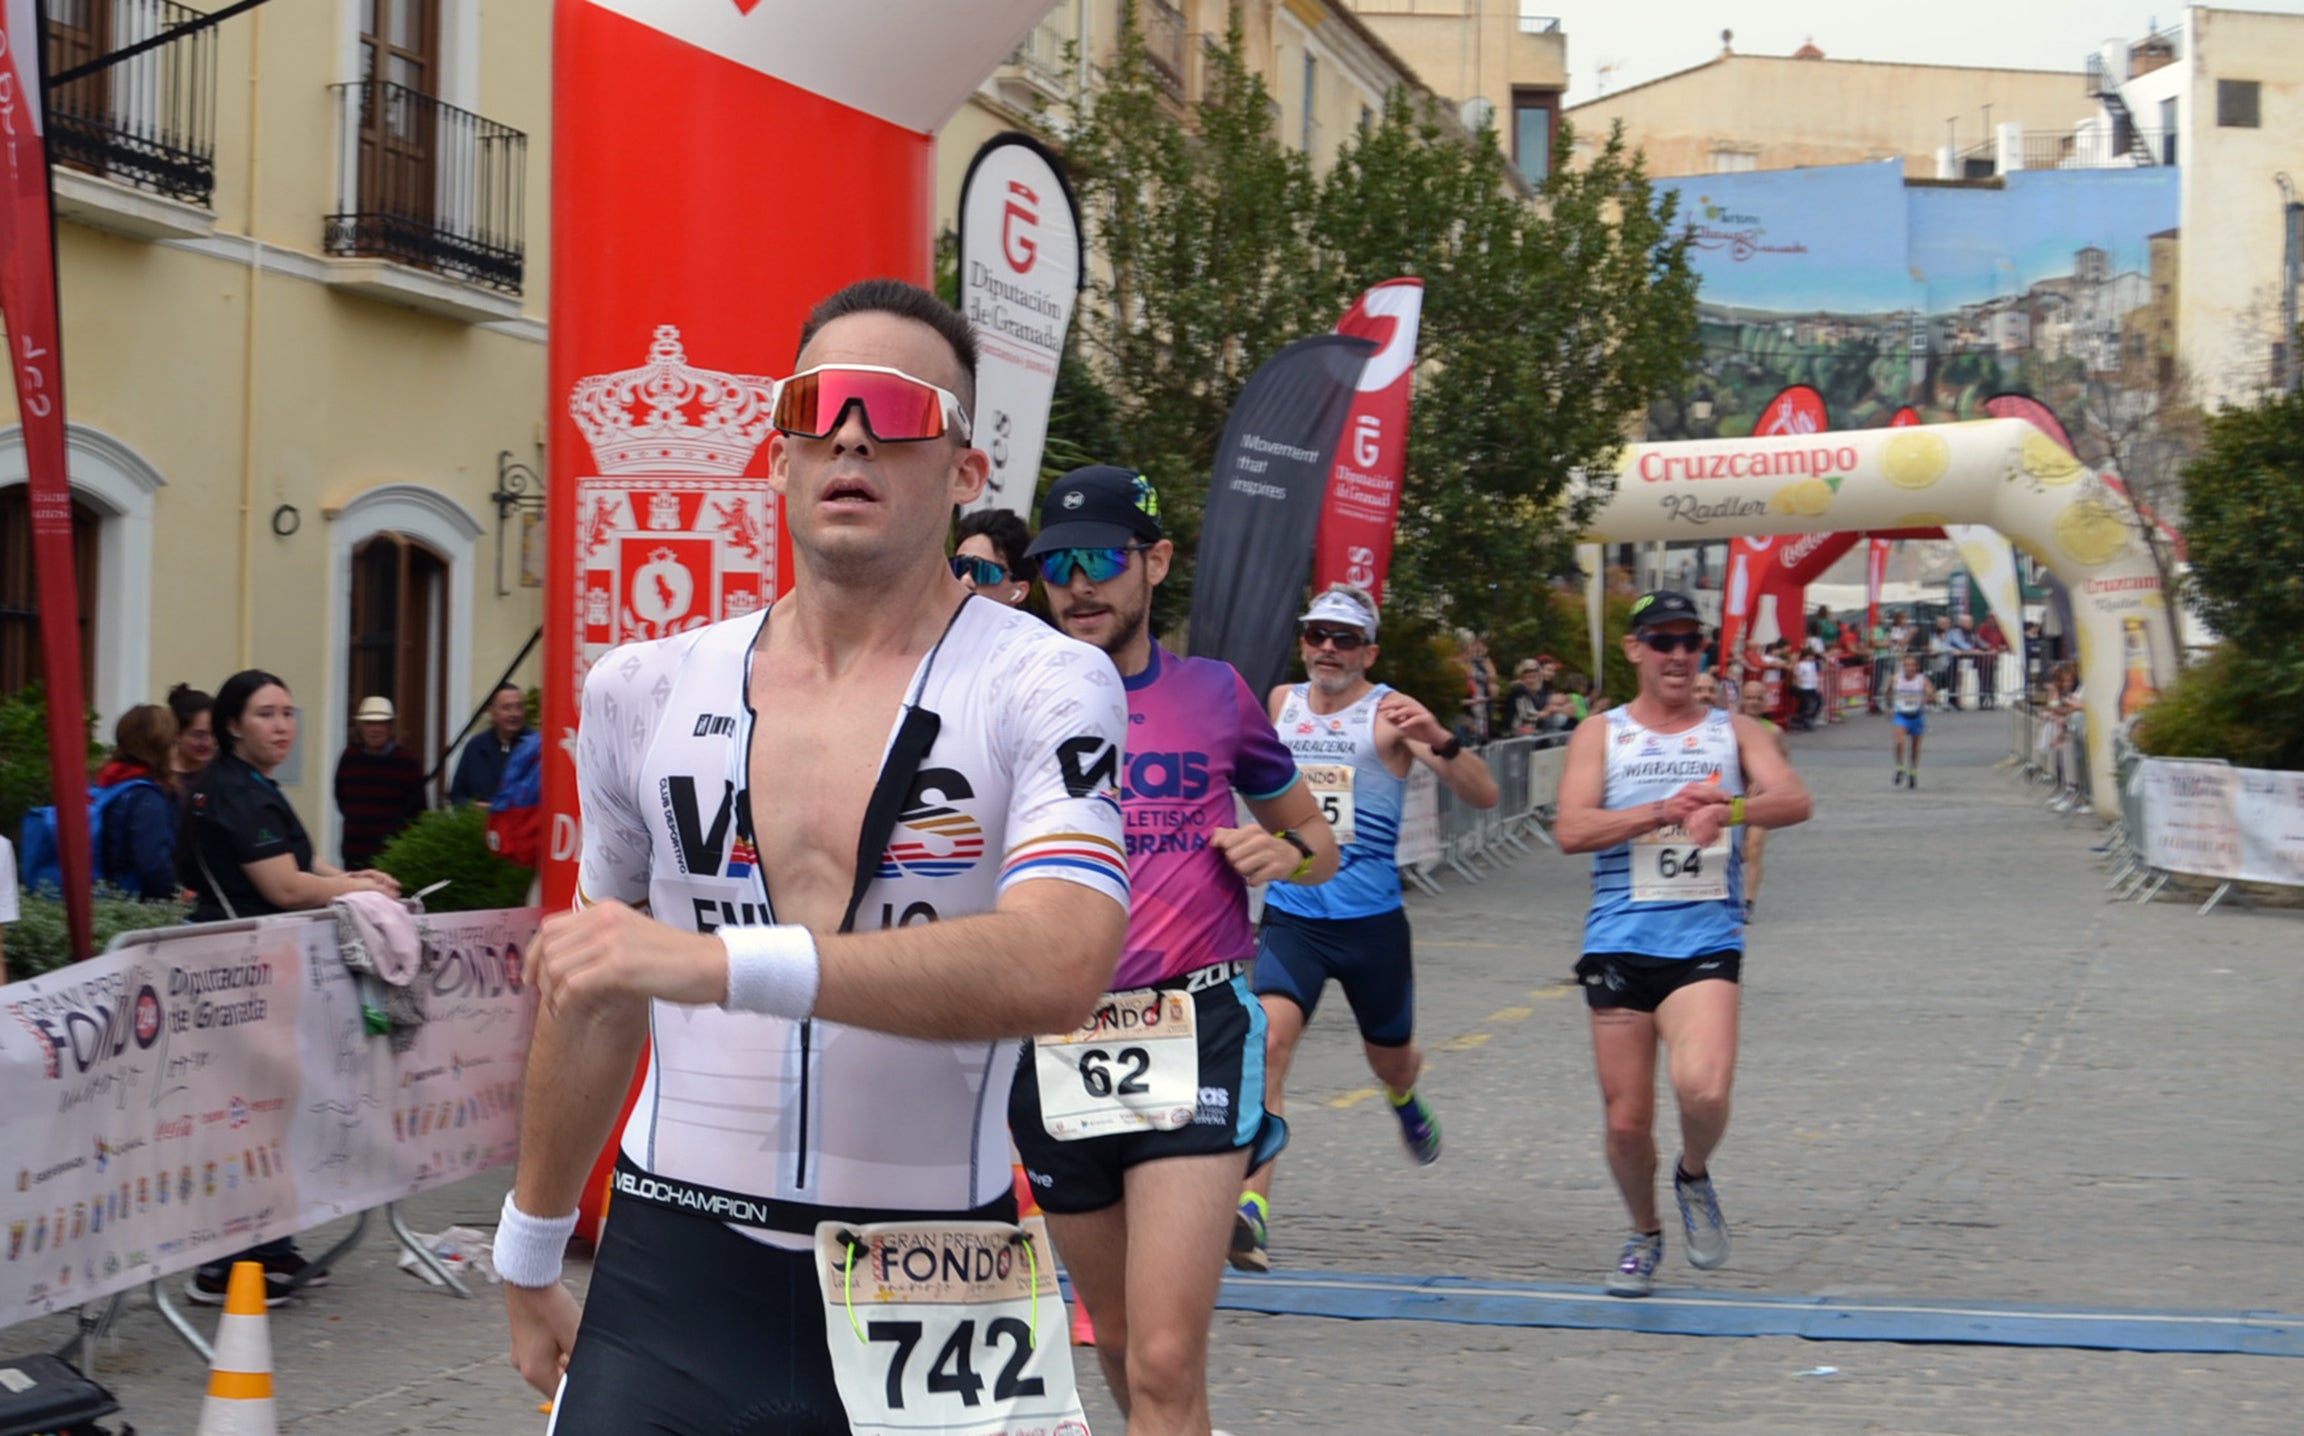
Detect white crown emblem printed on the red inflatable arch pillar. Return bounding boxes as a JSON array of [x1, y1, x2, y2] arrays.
[[569, 325, 776, 477]]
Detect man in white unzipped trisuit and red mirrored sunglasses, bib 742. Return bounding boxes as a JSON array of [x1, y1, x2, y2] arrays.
[[495, 279, 1127, 1436]]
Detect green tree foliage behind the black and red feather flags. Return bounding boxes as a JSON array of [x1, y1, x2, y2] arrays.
[[1051, 7, 1698, 705]]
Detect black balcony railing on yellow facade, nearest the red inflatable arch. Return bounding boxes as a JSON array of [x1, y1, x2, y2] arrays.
[[327, 81, 528, 295]]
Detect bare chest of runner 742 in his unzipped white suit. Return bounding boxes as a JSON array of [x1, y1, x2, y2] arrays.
[[746, 648, 919, 931]]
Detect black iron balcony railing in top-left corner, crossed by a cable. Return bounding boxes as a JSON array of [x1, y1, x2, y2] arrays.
[[46, 0, 217, 207]]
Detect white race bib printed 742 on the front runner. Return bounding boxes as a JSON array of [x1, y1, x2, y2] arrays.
[[816, 1217, 1087, 1436]]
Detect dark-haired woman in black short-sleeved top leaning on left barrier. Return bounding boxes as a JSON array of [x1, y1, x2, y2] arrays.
[[177, 668, 401, 1307]]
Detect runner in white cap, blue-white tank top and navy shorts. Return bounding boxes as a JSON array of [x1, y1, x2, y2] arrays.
[[1233, 583, 1495, 1272]]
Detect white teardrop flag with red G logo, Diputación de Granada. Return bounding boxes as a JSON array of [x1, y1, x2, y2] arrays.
[[958, 134, 1087, 519]]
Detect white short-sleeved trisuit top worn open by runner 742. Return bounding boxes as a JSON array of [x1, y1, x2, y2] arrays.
[[576, 599, 1129, 1247]]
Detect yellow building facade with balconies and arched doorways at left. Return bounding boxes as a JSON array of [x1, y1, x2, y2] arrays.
[[0, 0, 551, 855]]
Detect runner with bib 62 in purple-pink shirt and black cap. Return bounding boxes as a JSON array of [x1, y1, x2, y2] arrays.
[[1009, 463, 1336, 1436]]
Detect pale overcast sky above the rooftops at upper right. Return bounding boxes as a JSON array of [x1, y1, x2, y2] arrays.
[[1523, 0, 2304, 104]]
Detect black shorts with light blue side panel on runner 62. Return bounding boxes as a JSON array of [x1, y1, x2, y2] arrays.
[[1009, 975, 1283, 1215]]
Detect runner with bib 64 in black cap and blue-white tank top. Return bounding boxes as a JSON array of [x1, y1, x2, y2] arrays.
[[1553, 592, 1809, 1295]]
